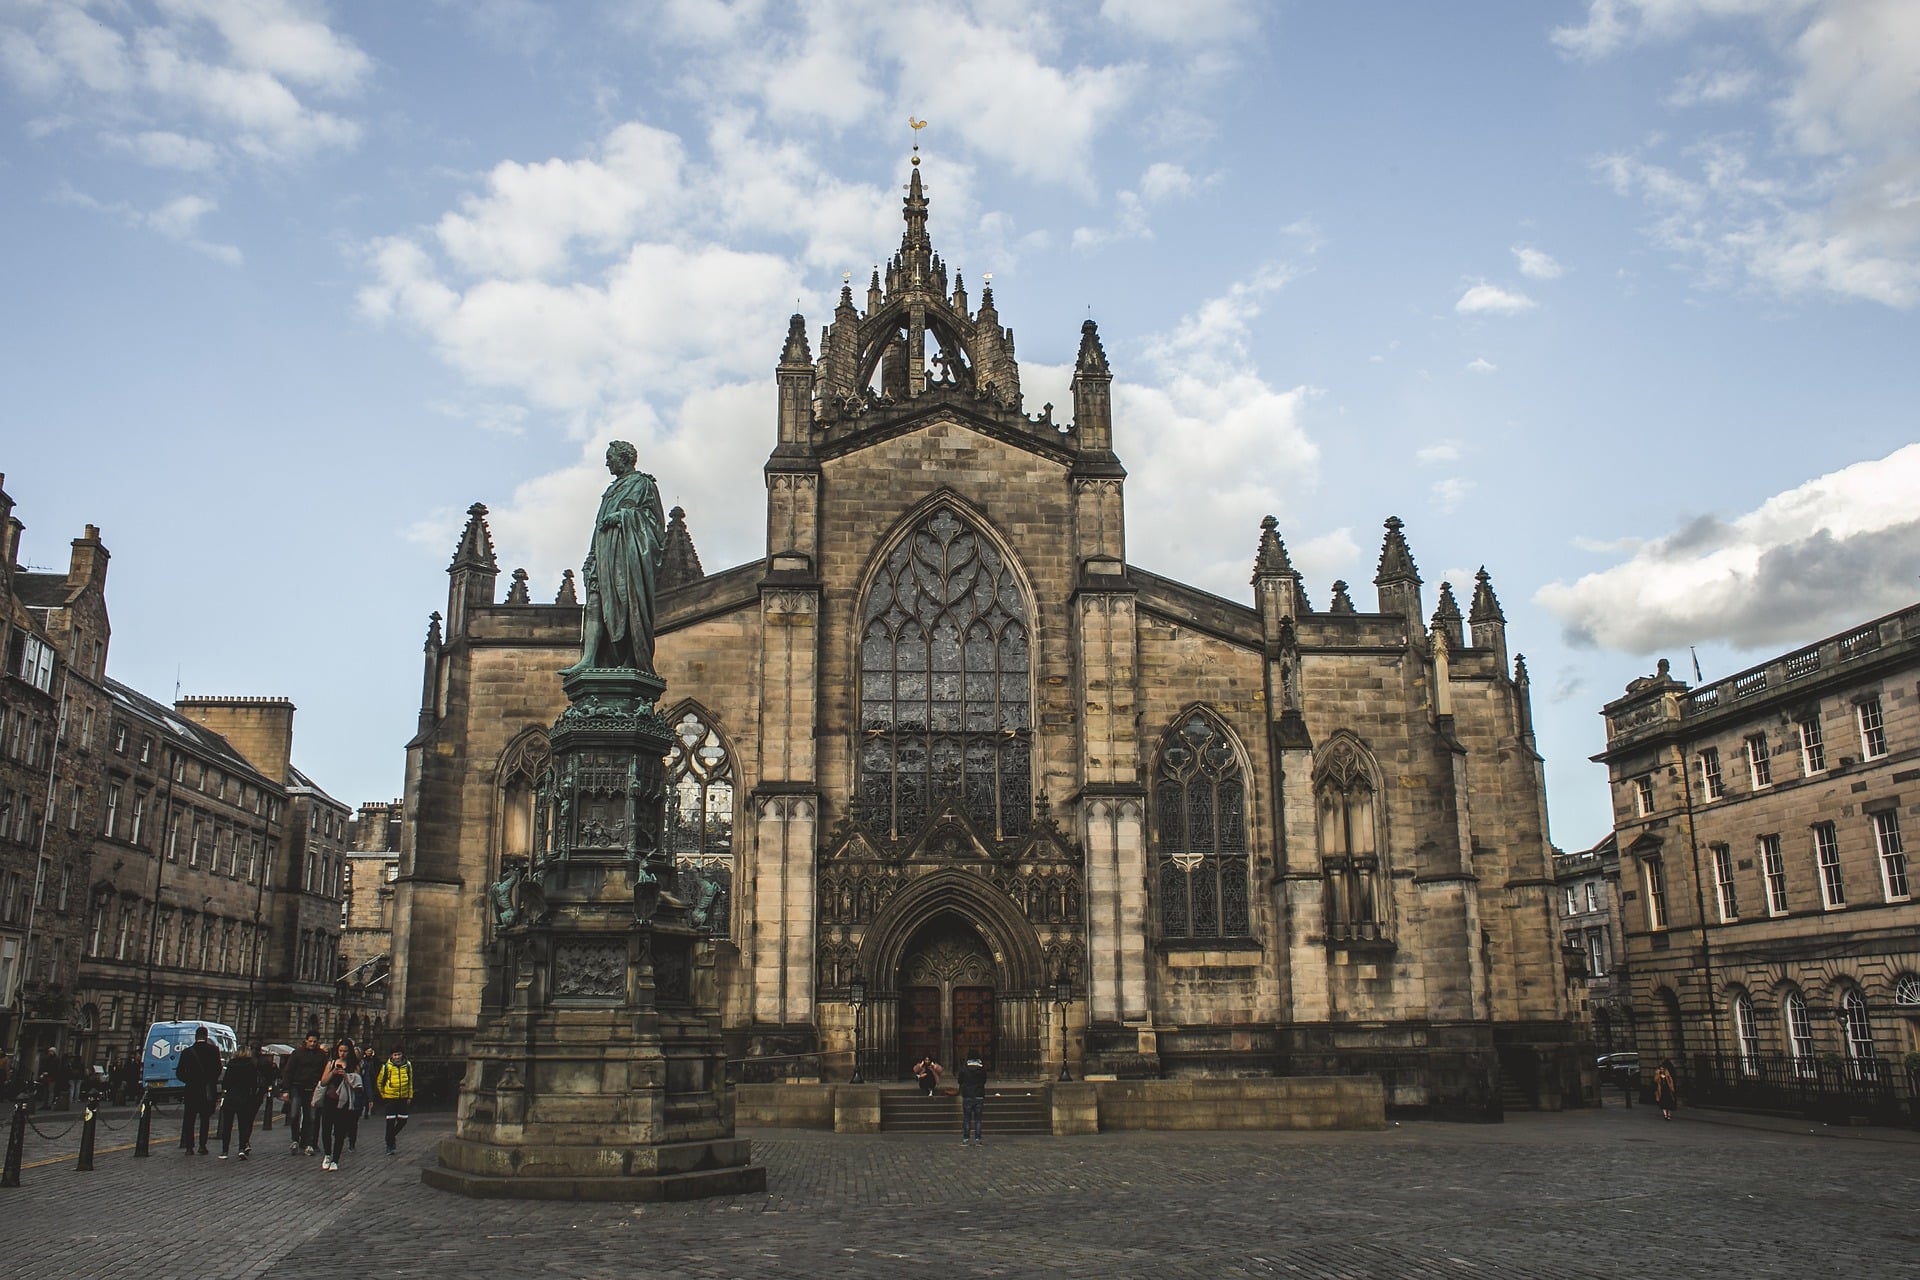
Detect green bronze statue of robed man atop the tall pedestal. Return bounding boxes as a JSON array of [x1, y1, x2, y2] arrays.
[[561, 439, 666, 676]]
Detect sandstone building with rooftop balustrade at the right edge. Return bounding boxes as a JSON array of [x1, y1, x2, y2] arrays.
[[1596, 606, 1920, 1080]]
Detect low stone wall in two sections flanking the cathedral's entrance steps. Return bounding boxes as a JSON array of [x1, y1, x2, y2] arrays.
[[733, 1077, 1386, 1136]]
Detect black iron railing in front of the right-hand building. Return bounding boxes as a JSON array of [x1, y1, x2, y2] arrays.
[[1681, 1054, 1920, 1128]]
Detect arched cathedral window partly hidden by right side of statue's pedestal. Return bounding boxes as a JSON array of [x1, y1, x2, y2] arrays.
[[666, 704, 733, 935]]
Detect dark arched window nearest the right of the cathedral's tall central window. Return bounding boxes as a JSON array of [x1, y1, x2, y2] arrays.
[[1154, 712, 1250, 940]]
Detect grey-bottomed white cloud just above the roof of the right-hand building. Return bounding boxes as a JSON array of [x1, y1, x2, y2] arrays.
[[1534, 445, 1920, 654]]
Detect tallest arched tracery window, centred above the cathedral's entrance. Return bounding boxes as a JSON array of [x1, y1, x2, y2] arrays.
[[858, 509, 1033, 839]]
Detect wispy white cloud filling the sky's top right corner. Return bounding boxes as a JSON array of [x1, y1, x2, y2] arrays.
[[1555, 0, 1920, 309]]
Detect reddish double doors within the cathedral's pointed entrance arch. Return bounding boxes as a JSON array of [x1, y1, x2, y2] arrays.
[[897, 915, 996, 1075]]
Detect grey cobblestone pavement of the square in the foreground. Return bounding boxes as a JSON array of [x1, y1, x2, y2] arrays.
[[0, 1107, 1920, 1280]]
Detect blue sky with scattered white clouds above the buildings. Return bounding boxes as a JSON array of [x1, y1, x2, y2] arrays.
[[0, 0, 1920, 848]]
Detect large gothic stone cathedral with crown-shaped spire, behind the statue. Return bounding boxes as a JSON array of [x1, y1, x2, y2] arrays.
[[390, 157, 1574, 1115]]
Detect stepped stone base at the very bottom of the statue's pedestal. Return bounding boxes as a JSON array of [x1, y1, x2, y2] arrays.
[[420, 1138, 766, 1201]]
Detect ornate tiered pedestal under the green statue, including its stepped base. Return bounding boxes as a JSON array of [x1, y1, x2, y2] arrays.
[[420, 670, 766, 1199]]
